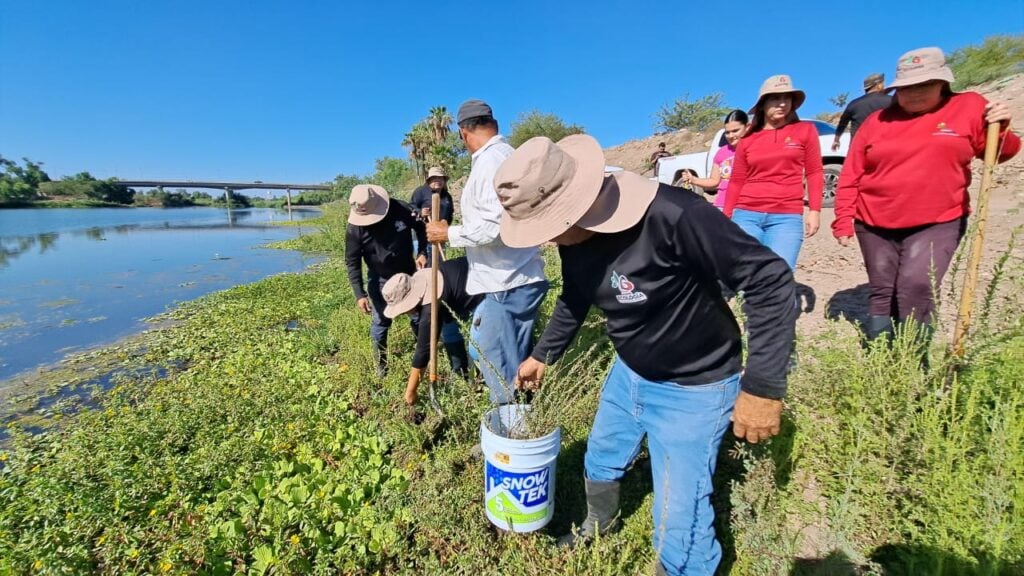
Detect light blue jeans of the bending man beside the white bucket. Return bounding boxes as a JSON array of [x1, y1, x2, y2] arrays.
[[584, 357, 739, 575]]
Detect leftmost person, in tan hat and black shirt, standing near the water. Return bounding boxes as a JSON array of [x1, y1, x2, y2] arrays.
[[345, 184, 427, 377]]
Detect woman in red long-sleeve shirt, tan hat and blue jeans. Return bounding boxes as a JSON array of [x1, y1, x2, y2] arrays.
[[724, 74, 824, 270]]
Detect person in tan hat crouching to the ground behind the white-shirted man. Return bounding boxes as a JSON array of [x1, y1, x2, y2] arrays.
[[384, 257, 483, 406]]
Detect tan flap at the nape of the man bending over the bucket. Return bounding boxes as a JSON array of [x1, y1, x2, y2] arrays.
[[575, 171, 658, 234]]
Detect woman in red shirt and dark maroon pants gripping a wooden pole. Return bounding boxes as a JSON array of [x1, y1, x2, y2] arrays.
[[833, 48, 1021, 339]]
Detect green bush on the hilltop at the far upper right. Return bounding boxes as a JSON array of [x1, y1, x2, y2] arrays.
[[947, 34, 1024, 90]]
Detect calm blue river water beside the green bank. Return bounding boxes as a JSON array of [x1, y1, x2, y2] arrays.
[[0, 208, 319, 380]]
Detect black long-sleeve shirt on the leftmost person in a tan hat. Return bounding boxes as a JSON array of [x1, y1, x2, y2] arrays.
[[345, 198, 428, 298]]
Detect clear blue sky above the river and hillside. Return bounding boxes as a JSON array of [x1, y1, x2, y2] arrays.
[[0, 0, 1024, 182]]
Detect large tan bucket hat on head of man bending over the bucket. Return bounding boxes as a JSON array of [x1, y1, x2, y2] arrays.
[[495, 134, 604, 248]]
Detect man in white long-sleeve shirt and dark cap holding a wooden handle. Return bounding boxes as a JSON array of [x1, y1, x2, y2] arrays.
[[427, 100, 548, 404]]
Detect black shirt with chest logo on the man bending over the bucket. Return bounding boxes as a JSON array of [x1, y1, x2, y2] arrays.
[[531, 184, 798, 398]]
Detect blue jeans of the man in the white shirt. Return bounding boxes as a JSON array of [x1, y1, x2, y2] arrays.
[[469, 280, 548, 404]]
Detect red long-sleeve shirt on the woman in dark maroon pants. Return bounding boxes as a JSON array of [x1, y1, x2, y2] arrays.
[[833, 92, 1021, 238]]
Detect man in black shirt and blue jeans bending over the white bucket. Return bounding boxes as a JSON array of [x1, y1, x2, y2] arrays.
[[495, 135, 798, 575]]
